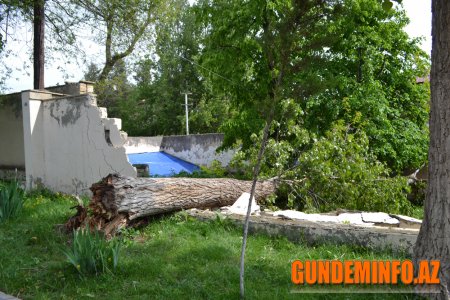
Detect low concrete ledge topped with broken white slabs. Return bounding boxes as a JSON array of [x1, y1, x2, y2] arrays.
[[187, 193, 422, 254]]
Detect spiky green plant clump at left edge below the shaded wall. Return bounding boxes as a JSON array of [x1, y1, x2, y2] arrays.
[[0, 180, 25, 223]]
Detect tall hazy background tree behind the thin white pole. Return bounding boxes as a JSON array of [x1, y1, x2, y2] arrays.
[[119, 0, 214, 135]]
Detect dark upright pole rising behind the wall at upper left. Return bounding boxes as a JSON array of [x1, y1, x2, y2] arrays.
[[33, 0, 45, 90]]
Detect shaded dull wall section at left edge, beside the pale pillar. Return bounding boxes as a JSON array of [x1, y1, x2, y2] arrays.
[[0, 95, 25, 170]]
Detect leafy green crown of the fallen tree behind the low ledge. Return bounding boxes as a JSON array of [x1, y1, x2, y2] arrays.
[[233, 122, 412, 214]]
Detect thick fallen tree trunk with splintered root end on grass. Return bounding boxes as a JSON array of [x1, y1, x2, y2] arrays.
[[66, 175, 276, 234]]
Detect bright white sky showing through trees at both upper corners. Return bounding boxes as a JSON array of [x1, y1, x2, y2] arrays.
[[0, 0, 431, 93]]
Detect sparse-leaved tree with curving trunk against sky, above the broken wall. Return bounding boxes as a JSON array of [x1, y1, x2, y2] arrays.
[[0, 0, 165, 86]]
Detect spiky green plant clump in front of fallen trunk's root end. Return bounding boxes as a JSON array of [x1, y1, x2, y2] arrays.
[[63, 229, 120, 275]]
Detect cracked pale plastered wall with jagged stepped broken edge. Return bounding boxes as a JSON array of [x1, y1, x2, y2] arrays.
[[22, 82, 136, 194]]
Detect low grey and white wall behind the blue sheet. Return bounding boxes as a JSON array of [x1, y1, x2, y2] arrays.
[[125, 133, 235, 166]]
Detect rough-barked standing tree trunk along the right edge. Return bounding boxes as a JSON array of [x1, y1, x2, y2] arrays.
[[414, 0, 450, 299]]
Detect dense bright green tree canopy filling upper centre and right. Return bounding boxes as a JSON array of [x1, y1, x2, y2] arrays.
[[200, 0, 429, 172]]
